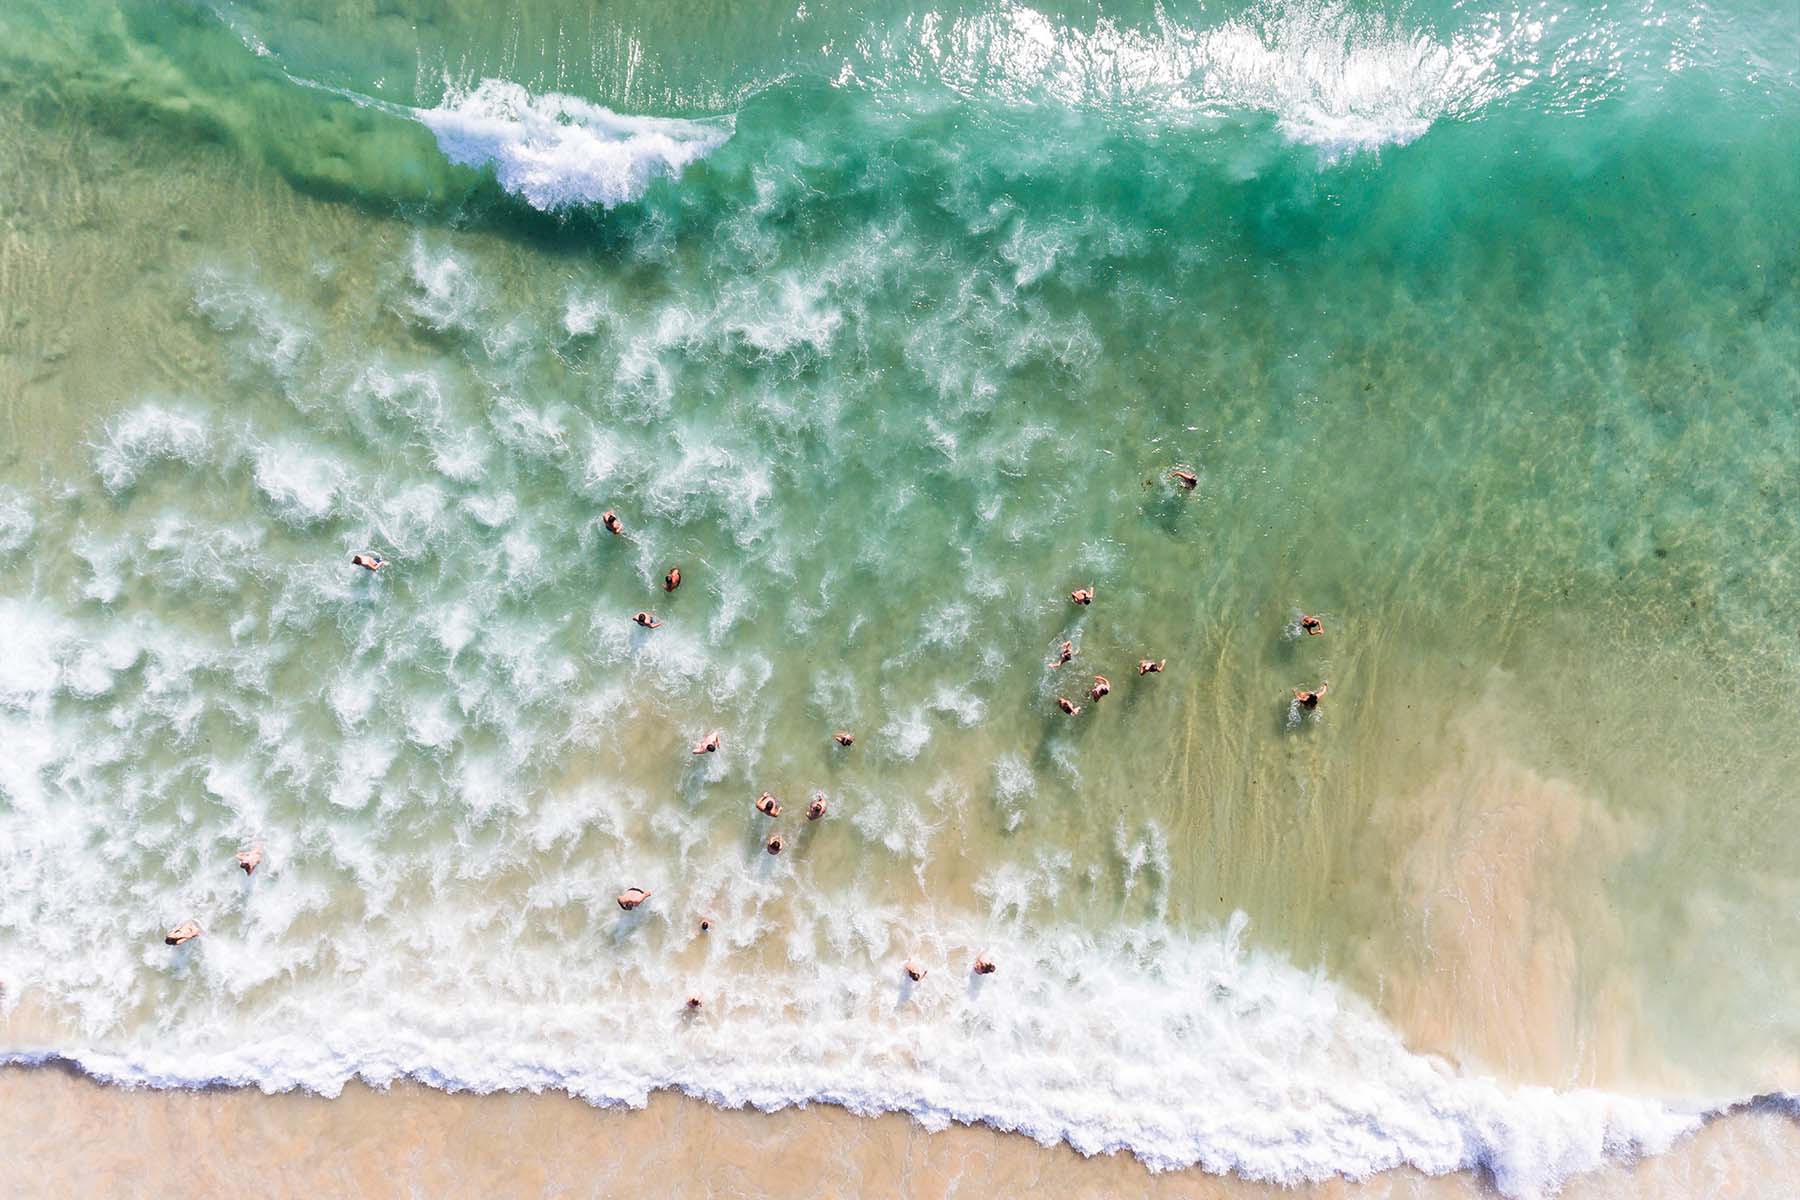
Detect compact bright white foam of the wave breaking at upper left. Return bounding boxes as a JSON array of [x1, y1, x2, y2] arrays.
[[414, 79, 733, 212]]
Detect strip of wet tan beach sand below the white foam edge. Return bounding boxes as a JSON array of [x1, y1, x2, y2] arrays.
[[0, 1067, 1800, 1200]]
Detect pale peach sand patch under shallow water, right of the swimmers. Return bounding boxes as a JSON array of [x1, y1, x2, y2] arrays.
[[1357, 680, 1656, 1092]]
